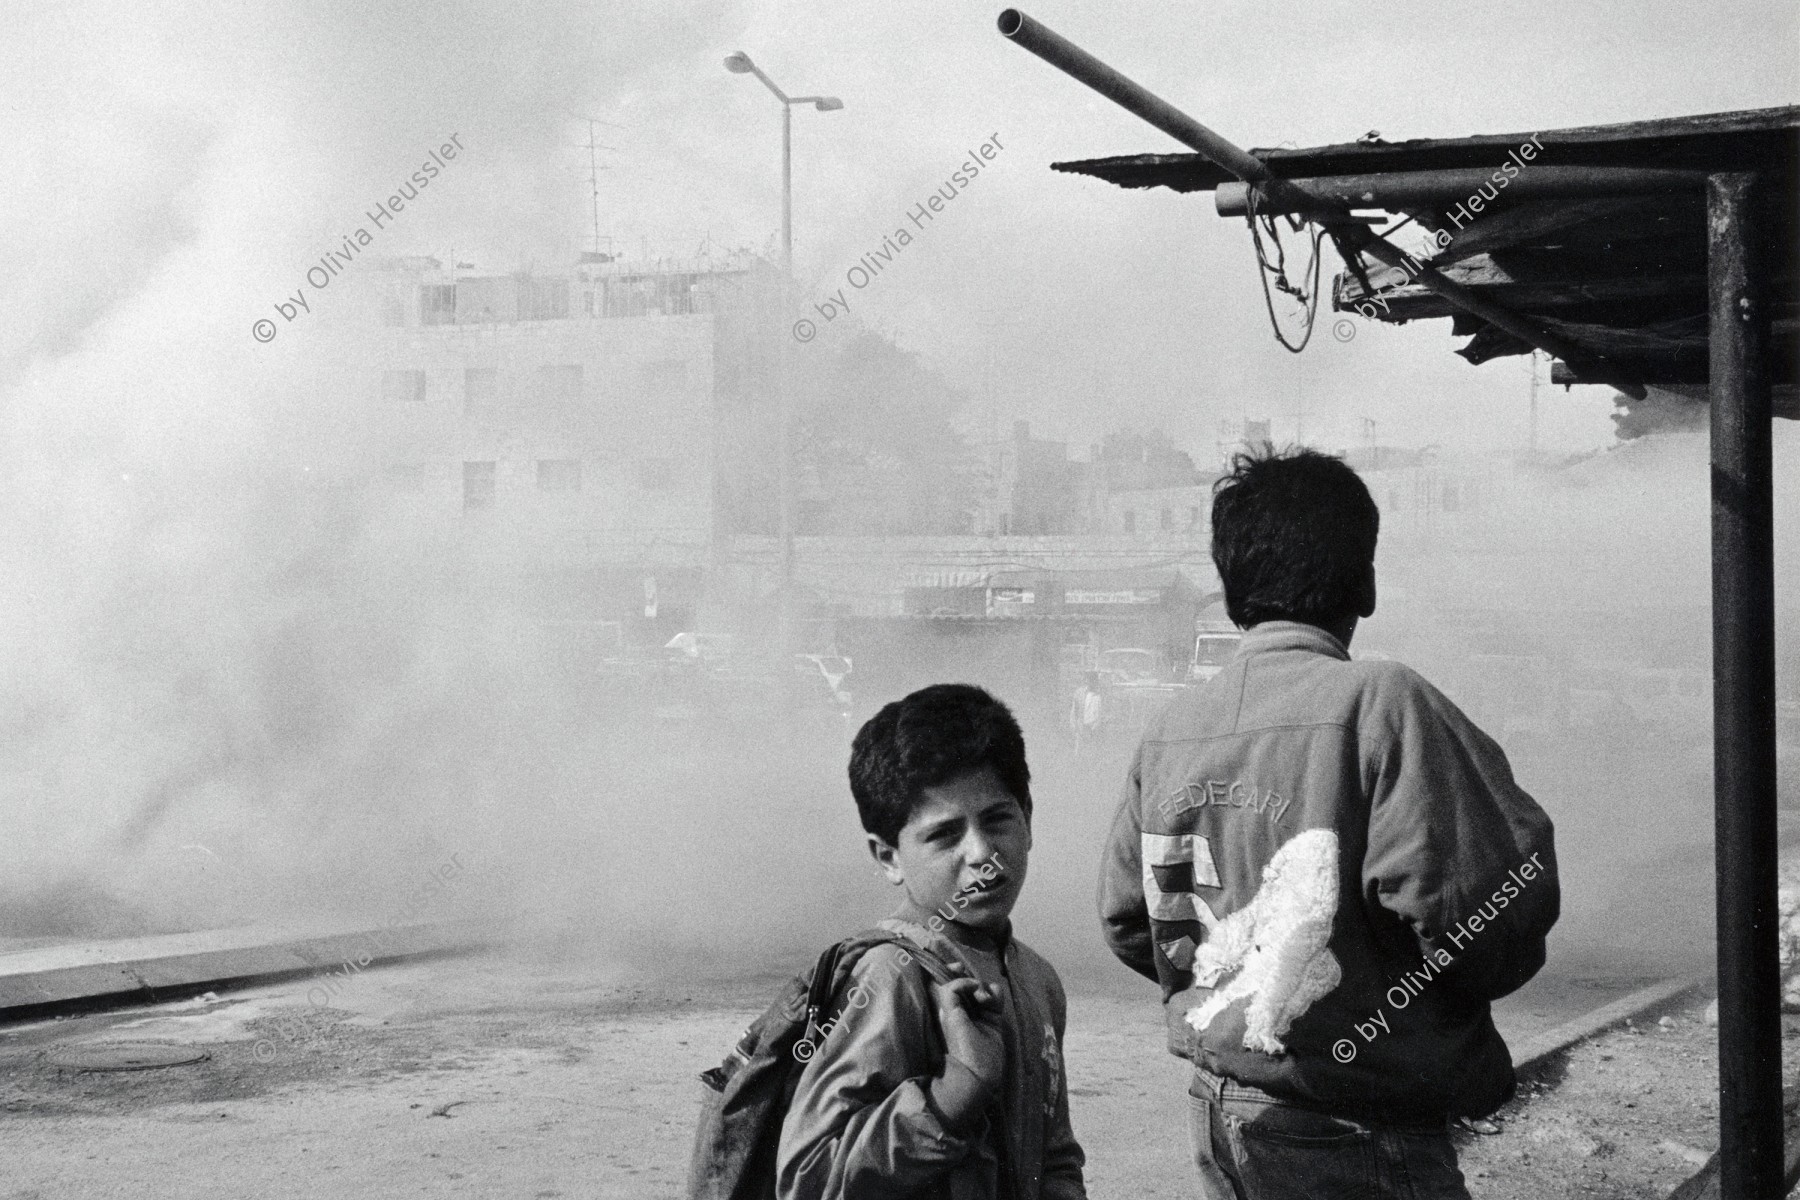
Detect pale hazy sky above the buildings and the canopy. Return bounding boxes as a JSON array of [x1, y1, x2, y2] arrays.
[[10, 0, 1800, 464]]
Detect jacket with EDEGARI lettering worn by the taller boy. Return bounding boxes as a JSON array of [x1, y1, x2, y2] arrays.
[[1100, 621, 1559, 1119]]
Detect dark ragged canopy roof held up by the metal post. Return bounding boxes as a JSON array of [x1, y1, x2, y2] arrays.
[[1051, 106, 1800, 417]]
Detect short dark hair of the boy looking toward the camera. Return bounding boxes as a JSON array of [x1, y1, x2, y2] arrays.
[[850, 684, 1031, 846]]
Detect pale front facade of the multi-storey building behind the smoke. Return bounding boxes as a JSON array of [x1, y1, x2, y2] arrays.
[[367, 257, 751, 624]]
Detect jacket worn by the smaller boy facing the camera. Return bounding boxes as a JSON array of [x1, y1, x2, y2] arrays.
[[778, 919, 1087, 1200]]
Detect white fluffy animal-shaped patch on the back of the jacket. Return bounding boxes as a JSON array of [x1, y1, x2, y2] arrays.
[[1188, 829, 1343, 1054]]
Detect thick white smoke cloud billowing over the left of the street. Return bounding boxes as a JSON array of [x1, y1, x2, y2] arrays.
[[0, 4, 745, 937]]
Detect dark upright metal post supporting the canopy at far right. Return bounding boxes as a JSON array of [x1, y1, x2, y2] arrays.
[[1706, 173, 1782, 1200]]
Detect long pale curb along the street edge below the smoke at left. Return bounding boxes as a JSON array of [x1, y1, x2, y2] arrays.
[[0, 923, 490, 1022]]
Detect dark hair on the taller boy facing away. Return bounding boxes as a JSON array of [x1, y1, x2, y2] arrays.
[[1213, 444, 1381, 628]]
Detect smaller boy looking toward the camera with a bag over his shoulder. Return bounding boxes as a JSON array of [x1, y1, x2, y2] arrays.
[[776, 684, 1087, 1200]]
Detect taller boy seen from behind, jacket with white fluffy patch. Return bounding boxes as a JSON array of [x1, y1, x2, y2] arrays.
[[1100, 448, 1559, 1200]]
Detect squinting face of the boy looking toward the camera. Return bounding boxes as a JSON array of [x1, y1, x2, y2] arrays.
[[869, 766, 1031, 936]]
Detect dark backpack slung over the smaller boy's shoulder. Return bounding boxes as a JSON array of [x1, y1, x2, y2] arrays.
[[688, 930, 950, 1200]]
